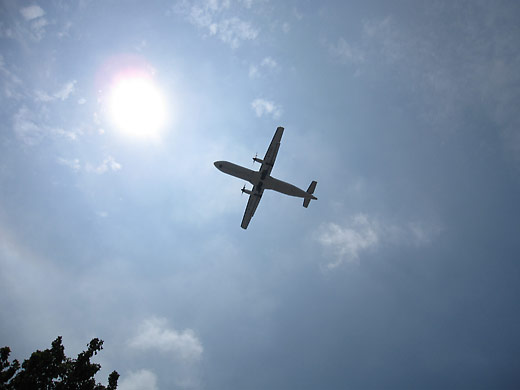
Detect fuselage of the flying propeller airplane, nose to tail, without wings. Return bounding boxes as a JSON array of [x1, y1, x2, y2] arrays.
[[214, 161, 316, 199]]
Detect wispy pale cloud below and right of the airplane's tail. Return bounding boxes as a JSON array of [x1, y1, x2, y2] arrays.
[[316, 213, 440, 269]]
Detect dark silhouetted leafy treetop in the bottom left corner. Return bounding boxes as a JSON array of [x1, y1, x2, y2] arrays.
[[0, 336, 119, 390]]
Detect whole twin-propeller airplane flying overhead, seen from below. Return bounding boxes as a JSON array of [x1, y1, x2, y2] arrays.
[[214, 127, 318, 229]]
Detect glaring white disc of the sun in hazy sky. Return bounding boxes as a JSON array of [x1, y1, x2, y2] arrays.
[[109, 75, 166, 138]]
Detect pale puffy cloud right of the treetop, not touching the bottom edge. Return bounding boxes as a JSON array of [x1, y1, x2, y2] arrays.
[[129, 317, 204, 361]]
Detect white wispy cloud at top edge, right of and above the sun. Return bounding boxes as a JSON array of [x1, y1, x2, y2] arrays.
[[174, 0, 258, 49]]
